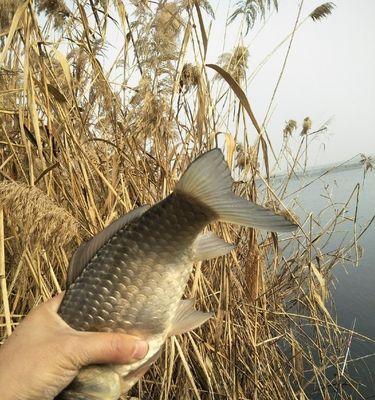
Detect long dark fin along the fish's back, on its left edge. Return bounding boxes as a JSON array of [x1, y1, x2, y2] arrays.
[[67, 205, 150, 286]]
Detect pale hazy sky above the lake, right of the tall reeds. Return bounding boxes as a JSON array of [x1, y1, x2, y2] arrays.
[[207, 0, 375, 164]]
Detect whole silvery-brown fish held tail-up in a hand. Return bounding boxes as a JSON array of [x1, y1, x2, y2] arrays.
[[56, 149, 297, 400]]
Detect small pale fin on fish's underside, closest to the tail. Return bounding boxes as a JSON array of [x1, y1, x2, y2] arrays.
[[193, 232, 236, 261]]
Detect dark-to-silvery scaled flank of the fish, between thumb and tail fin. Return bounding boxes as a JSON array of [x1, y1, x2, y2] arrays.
[[59, 194, 211, 336]]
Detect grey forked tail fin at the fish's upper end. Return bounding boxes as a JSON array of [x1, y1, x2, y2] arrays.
[[175, 149, 297, 232]]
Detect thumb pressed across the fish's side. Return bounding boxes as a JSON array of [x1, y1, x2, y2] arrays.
[[74, 332, 148, 366]]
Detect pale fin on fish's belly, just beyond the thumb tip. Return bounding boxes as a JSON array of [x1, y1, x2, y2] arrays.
[[169, 299, 214, 336]]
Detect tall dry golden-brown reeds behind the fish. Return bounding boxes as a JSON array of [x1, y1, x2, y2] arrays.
[[0, 0, 370, 400]]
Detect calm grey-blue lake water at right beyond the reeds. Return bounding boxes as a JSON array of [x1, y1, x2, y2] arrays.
[[280, 168, 375, 399]]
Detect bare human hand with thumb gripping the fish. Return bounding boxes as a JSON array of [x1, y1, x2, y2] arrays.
[[0, 293, 148, 400]]
